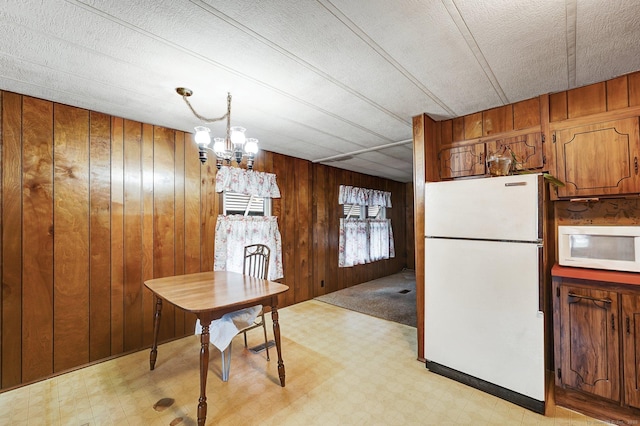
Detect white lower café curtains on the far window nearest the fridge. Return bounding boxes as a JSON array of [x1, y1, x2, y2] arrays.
[[338, 219, 396, 268]]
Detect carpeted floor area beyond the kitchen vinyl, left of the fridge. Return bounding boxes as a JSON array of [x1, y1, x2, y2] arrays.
[[316, 269, 417, 327]]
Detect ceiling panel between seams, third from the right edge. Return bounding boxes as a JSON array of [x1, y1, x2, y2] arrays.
[[325, 0, 508, 118]]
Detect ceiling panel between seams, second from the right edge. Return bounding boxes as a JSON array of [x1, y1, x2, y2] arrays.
[[455, 0, 568, 106]]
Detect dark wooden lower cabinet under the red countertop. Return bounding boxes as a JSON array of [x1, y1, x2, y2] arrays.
[[552, 267, 640, 421]]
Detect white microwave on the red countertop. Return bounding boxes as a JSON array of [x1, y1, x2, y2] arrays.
[[558, 226, 640, 272]]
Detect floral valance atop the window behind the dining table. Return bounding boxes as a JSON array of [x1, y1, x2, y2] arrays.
[[216, 166, 280, 198]]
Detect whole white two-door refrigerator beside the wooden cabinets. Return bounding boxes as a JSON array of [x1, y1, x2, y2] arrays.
[[424, 174, 545, 413]]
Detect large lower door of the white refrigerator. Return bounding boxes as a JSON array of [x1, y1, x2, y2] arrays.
[[424, 238, 545, 401]]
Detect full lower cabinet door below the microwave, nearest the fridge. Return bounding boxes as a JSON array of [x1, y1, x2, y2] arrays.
[[560, 285, 620, 401]]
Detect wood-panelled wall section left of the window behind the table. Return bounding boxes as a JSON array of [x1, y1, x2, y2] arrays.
[[0, 92, 208, 388]]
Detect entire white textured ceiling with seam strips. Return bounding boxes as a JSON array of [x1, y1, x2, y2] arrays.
[[0, 0, 640, 182]]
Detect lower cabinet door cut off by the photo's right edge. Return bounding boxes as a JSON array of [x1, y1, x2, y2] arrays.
[[622, 294, 640, 408]]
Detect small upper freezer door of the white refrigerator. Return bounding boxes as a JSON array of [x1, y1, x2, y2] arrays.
[[425, 174, 542, 241]]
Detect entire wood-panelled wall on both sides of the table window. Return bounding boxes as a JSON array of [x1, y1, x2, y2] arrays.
[[0, 92, 412, 389]]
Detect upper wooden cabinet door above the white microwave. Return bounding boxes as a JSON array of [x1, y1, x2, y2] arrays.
[[554, 117, 640, 197]]
